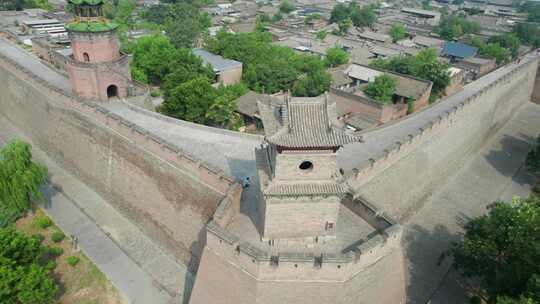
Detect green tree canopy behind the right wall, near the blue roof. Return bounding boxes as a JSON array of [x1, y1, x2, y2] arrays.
[[371, 48, 450, 100]]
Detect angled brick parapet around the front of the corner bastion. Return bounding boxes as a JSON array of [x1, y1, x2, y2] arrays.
[[206, 221, 402, 282]]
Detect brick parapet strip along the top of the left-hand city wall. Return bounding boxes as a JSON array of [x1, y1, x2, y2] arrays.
[[0, 54, 235, 195]]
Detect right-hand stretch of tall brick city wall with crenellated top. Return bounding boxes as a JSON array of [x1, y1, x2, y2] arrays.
[[348, 56, 538, 220]]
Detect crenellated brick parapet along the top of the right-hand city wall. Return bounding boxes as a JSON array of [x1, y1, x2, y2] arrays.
[[343, 52, 538, 189]]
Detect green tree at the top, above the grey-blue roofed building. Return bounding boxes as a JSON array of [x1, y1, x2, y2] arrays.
[[164, 2, 212, 48]]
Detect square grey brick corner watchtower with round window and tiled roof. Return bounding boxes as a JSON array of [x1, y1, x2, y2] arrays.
[[257, 96, 359, 242]]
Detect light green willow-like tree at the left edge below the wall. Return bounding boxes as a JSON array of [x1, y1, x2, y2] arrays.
[[0, 140, 47, 227]]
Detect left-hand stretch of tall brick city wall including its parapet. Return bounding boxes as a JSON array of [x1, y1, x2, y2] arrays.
[[0, 55, 241, 264]]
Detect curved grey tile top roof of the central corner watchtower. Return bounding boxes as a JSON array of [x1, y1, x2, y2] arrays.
[[267, 96, 359, 149]]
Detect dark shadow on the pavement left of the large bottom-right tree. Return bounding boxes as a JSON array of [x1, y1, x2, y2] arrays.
[[403, 223, 468, 304]]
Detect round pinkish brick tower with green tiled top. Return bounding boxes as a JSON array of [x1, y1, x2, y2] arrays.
[[66, 0, 131, 101]]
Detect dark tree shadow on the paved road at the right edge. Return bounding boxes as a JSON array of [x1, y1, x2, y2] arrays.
[[485, 134, 535, 186]]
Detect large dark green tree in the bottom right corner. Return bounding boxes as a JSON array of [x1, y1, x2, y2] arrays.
[[451, 198, 540, 303]]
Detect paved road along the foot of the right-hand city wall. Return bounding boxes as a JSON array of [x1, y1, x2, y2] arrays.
[[404, 103, 540, 304]]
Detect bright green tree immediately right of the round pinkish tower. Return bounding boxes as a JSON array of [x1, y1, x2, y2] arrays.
[[130, 35, 176, 85]]
